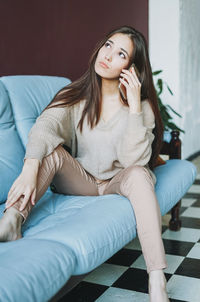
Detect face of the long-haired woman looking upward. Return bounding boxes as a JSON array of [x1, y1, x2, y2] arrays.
[[94, 33, 133, 79]]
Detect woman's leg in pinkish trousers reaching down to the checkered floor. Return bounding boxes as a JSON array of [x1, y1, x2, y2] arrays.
[[101, 166, 169, 302]]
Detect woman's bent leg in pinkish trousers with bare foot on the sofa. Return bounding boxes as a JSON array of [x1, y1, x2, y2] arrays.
[[0, 145, 98, 241]]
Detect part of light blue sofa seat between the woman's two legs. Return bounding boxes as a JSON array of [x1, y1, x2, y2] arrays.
[[19, 194, 136, 275]]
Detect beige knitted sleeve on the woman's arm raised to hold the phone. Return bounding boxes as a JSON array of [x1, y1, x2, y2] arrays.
[[117, 100, 155, 168]]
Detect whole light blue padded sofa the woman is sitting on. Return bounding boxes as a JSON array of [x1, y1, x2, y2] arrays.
[[0, 76, 196, 302]]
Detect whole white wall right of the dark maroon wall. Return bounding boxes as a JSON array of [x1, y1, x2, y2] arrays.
[[149, 0, 200, 158]]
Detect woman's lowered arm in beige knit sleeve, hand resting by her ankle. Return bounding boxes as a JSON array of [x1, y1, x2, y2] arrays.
[[6, 107, 71, 209]]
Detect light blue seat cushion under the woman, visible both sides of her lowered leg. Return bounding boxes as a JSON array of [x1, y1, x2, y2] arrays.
[[0, 160, 196, 275]]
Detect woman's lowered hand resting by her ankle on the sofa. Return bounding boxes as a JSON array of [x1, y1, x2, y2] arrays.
[[6, 159, 39, 211]]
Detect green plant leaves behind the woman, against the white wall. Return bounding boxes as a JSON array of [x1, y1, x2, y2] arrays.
[[152, 70, 185, 133]]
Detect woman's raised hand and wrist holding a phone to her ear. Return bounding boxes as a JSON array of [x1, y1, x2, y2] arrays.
[[119, 67, 142, 113]]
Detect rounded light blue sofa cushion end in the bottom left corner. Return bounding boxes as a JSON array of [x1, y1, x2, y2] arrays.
[[0, 237, 76, 302]]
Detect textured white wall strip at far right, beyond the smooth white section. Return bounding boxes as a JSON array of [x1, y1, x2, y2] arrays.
[[179, 0, 200, 159]]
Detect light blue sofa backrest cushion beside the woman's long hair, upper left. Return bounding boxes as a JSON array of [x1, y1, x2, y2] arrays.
[[0, 75, 71, 146]]
